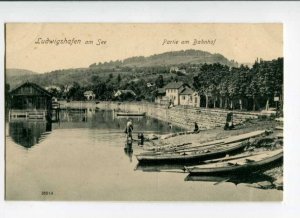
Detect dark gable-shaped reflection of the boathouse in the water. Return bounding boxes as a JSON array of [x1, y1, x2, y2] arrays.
[[9, 120, 52, 148]]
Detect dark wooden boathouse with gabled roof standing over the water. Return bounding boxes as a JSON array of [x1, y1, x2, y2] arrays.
[[9, 82, 52, 120]]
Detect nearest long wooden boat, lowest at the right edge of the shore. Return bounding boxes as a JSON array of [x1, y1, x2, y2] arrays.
[[185, 148, 283, 175]]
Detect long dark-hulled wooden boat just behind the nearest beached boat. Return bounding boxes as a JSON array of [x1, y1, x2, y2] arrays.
[[136, 142, 247, 164]]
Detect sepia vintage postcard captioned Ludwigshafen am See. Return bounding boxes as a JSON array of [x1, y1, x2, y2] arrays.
[[5, 23, 284, 201]]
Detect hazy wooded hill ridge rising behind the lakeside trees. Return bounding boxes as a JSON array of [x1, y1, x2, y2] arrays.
[[6, 50, 238, 89]]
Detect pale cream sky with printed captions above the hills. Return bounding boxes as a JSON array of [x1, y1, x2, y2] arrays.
[[6, 23, 283, 73]]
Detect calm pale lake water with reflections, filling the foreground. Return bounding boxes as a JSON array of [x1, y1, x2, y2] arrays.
[[6, 109, 282, 201]]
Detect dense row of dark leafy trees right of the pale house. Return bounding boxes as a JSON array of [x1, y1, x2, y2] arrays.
[[193, 58, 283, 110]]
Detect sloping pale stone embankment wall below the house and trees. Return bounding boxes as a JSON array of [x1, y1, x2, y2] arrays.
[[61, 101, 258, 130]]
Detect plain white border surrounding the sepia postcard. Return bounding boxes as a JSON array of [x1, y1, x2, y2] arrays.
[[0, 2, 300, 218]]
